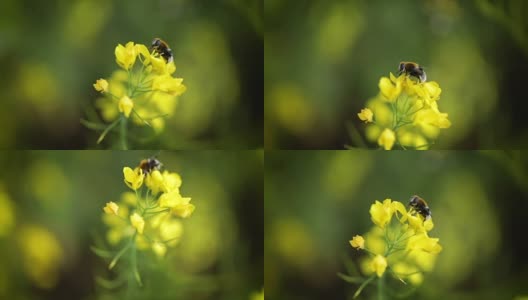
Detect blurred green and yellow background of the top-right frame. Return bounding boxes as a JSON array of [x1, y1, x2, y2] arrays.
[[264, 0, 528, 149]]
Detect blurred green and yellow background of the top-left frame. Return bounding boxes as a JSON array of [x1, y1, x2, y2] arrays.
[[0, 0, 264, 149]]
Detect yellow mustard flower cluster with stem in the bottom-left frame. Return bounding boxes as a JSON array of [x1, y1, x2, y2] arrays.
[[99, 162, 195, 284]]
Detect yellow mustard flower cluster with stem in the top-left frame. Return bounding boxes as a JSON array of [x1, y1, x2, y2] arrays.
[[89, 42, 186, 149]]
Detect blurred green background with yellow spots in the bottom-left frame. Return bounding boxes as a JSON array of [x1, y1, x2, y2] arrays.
[[0, 151, 264, 300]]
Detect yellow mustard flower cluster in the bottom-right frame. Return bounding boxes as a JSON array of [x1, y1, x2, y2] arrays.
[[349, 199, 442, 294]]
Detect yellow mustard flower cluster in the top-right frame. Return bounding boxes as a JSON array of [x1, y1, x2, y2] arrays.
[[358, 73, 451, 150]]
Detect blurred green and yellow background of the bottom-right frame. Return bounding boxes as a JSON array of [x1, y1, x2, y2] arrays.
[[264, 151, 528, 300]]
